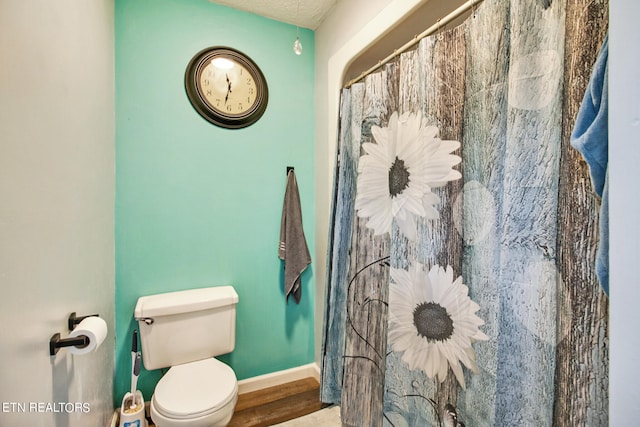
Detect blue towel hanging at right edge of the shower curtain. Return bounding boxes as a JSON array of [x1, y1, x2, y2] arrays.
[[571, 35, 609, 295]]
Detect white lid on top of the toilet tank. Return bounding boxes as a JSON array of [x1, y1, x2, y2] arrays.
[[134, 286, 238, 319]]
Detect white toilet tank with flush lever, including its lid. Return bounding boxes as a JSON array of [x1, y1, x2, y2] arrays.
[[134, 286, 238, 370]]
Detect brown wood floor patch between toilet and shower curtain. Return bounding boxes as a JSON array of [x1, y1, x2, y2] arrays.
[[229, 378, 326, 427]]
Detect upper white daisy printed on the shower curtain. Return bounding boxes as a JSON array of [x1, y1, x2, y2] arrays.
[[355, 112, 462, 240]]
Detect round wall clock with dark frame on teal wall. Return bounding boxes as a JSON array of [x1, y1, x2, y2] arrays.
[[184, 46, 269, 129]]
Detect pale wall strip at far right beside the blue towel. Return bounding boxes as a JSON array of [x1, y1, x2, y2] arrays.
[[609, 0, 640, 426]]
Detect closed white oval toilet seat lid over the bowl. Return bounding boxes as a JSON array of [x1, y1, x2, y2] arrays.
[[153, 358, 238, 418]]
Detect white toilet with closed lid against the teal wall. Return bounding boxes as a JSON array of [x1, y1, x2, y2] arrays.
[[135, 286, 238, 427]]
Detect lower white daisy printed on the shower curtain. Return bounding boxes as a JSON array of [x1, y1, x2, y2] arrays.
[[389, 264, 489, 388]]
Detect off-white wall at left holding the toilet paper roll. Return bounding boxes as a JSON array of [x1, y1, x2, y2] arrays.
[[0, 0, 115, 427]]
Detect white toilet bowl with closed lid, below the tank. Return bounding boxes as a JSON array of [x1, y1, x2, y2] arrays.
[[151, 358, 238, 427]]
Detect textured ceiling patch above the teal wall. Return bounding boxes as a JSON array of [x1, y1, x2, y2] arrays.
[[209, 0, 337, 30]]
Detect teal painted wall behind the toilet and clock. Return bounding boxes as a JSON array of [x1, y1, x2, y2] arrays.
[[114, 0, 317, 405]]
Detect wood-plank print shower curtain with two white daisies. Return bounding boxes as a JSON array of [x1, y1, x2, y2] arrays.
[[321, 0, 608, 426]]
